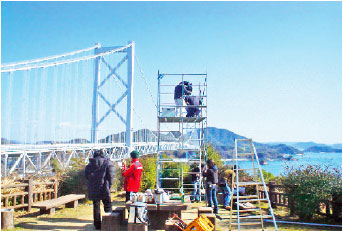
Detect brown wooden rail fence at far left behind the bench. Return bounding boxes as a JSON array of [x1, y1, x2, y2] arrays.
[[1, 179, 58, 211]]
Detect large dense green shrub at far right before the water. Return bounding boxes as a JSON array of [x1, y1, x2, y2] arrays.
[[282, 165, 342, 220]]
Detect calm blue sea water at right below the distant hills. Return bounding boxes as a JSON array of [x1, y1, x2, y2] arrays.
[[231, 152, 342, 176]]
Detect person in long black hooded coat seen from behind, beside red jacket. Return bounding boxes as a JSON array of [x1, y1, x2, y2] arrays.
[[85, 150, 114, 229]]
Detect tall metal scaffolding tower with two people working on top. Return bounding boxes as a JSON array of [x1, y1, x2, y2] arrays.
[[156, 72, 207, 199]]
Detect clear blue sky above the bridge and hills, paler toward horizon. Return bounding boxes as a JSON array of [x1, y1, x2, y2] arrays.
[[1, 2, 342, 143]]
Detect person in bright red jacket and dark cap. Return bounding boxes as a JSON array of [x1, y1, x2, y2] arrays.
[[121, 151, 143, 201]]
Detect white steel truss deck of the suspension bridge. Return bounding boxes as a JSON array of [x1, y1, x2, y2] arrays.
[[1, 142, 180, 176]]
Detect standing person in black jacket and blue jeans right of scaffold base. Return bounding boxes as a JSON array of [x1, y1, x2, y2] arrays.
[[202, 159, 218, 213]]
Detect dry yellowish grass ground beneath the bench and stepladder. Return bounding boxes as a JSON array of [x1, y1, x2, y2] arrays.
[[7, 198, 342, 231]]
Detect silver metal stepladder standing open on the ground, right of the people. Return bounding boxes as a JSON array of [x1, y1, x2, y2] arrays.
[[229, 139, 278, 231]]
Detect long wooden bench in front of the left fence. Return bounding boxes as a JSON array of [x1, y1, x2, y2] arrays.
[[32, 194, 86, 215]]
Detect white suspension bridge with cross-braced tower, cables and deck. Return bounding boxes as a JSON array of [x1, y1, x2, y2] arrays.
[[1, 42, 185, 176]]
